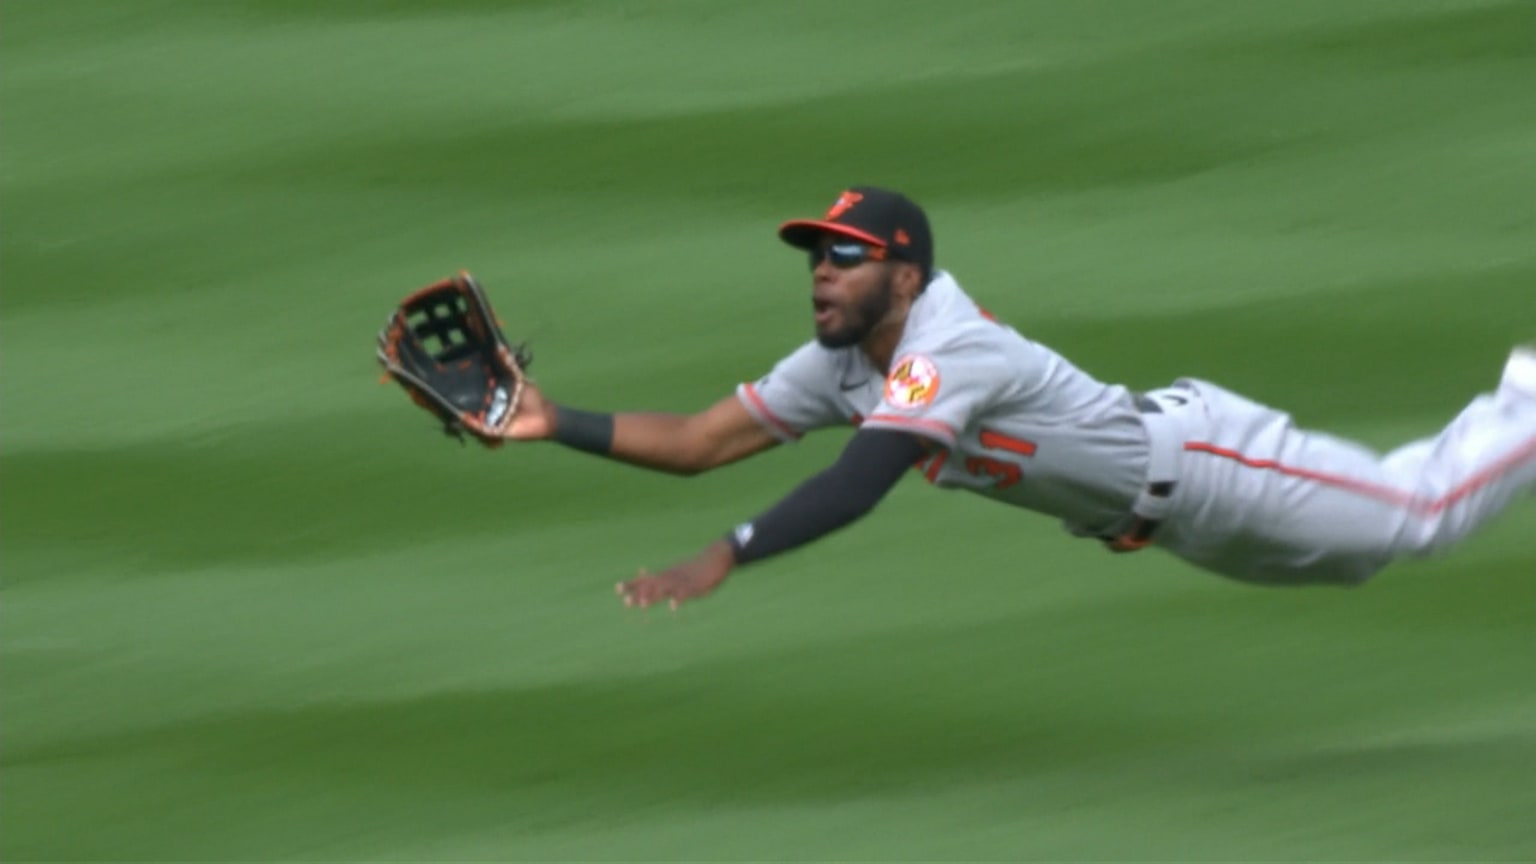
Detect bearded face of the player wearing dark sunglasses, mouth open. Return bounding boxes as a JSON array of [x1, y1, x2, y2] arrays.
[[811, 238, 895, 347]]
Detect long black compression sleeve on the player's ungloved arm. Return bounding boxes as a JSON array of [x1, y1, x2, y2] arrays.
[[727, 429, 926, 564]]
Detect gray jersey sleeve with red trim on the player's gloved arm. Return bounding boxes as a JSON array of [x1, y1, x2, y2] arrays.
[[736, 341, 845, 441]]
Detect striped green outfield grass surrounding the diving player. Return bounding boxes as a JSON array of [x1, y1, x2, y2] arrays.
[[0, 0, 1536, 861]]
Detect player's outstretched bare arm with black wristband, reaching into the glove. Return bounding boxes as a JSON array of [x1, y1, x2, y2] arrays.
[[494, 383, 779, 475]]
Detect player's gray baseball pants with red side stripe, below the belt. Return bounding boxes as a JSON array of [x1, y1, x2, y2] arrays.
[[1157, 345, 1536, 584]]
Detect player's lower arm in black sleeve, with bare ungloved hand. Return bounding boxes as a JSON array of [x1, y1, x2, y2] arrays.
[[616, 429, 928, 609]]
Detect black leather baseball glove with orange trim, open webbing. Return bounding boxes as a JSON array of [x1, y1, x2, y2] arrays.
[[378, 271, 533, 446]]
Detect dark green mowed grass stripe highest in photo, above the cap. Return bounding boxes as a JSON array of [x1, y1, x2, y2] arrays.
[[8, 6, 1528, 306]]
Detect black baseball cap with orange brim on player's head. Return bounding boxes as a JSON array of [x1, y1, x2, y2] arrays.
[[779, 186, 934, 276]]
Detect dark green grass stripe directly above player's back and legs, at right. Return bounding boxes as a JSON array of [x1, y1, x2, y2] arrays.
[[1007, 261, 1536, 424]]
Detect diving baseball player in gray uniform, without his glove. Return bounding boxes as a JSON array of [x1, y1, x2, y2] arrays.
[[488, 186, 1536, 607]]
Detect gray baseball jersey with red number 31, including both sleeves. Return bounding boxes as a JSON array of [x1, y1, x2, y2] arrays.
[[737, 271, 1147, 532]]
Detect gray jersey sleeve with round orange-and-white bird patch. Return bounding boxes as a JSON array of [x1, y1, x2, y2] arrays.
[[863, 328, 1012, 447]]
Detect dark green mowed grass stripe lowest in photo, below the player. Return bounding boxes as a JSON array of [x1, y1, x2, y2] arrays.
[[14, 547, 1528, 855]]
